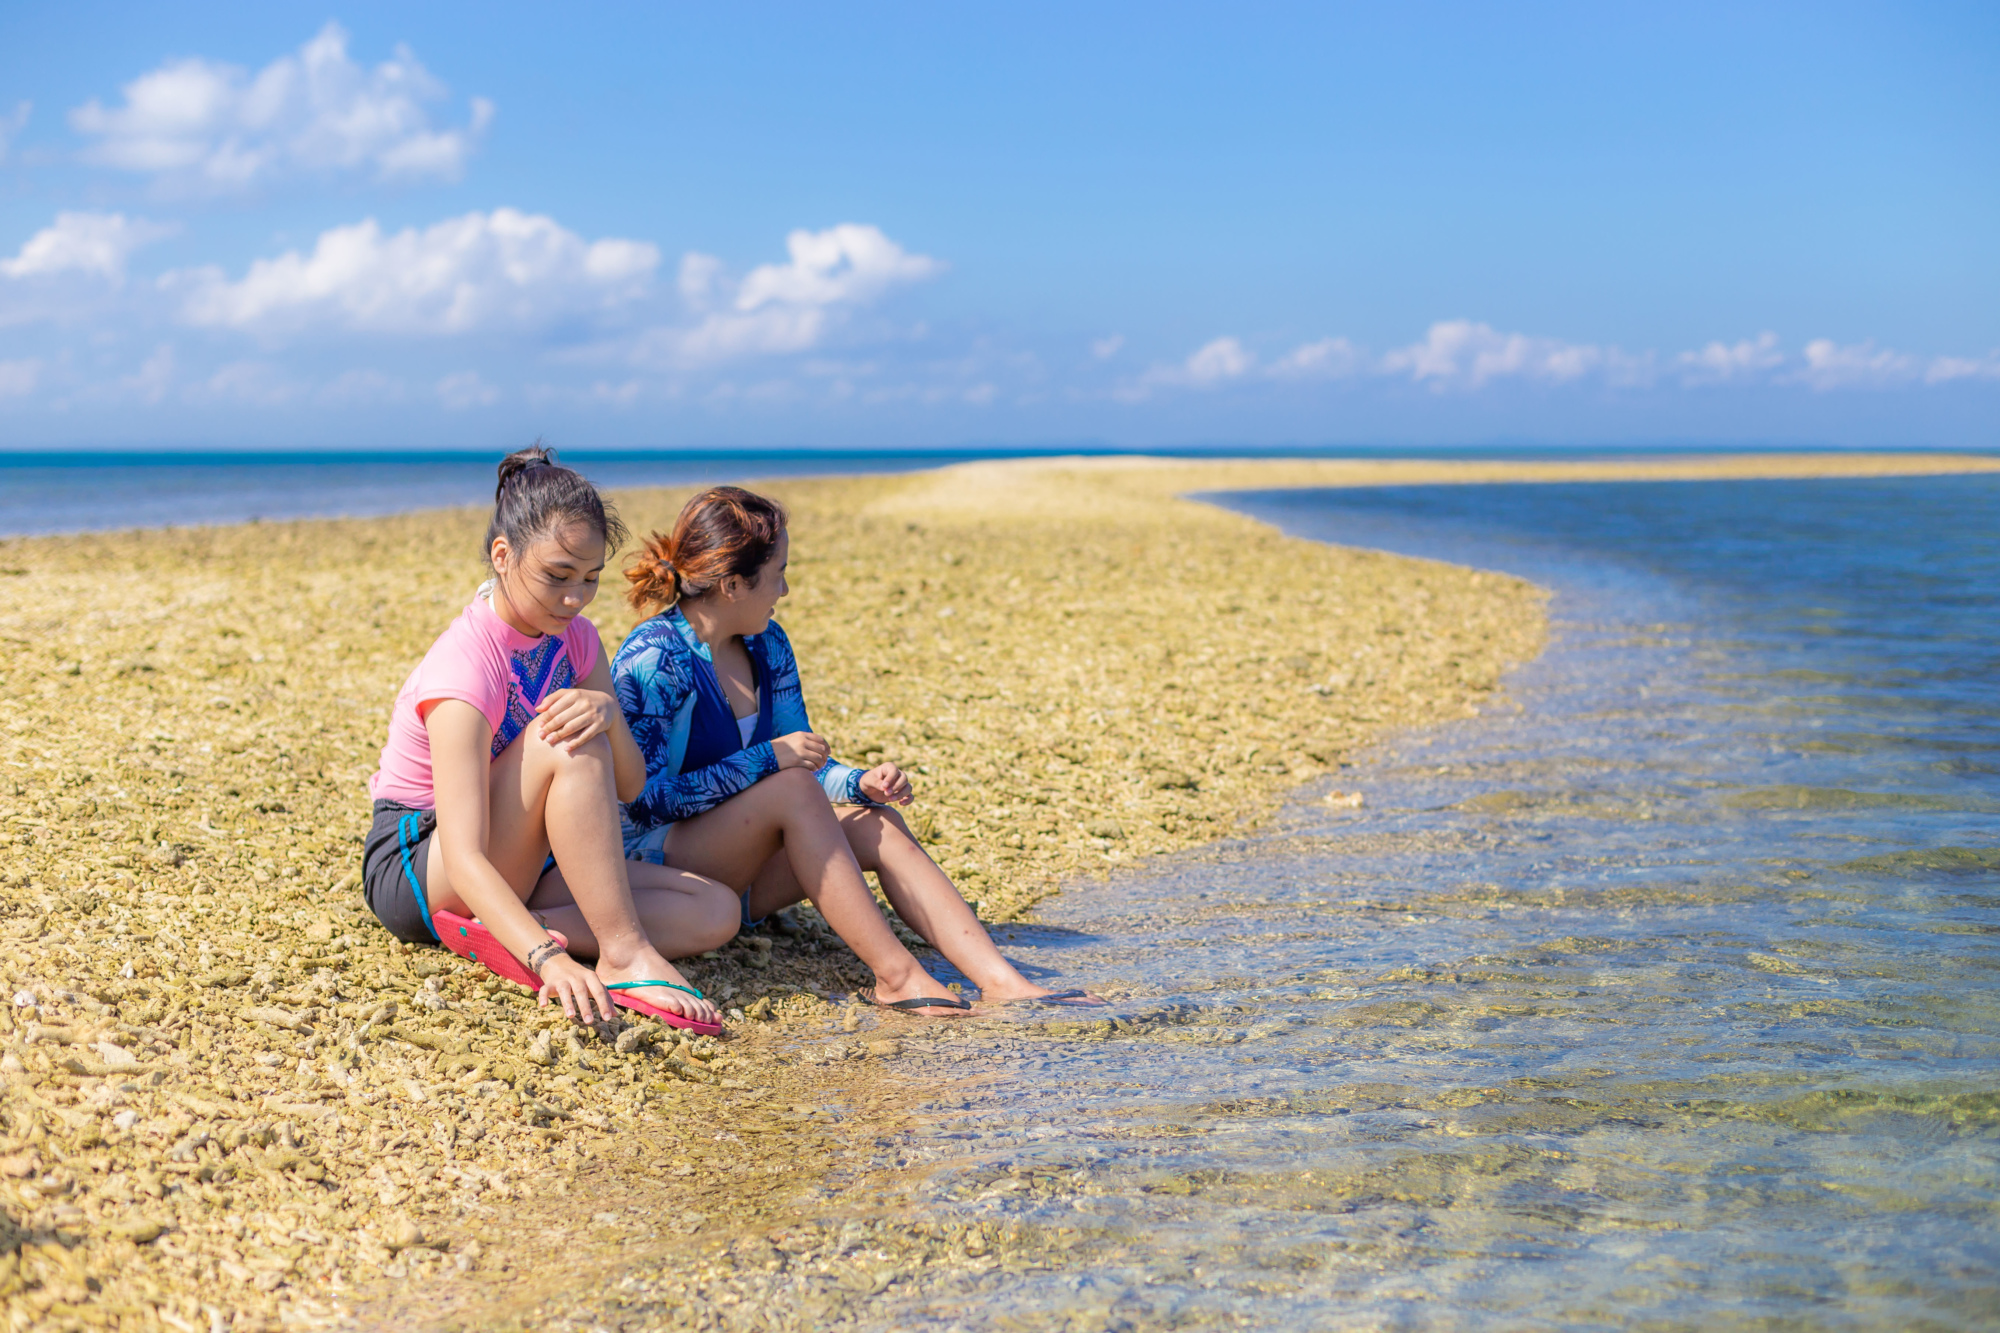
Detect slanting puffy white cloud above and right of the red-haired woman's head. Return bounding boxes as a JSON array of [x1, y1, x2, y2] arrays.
[[634, 222, 944, 364]]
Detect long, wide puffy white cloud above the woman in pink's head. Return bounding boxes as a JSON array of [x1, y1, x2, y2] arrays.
[[177, 208, 660, 334]]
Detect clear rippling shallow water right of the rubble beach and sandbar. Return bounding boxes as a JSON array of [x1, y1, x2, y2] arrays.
[[870, 478, 2000, 1329]]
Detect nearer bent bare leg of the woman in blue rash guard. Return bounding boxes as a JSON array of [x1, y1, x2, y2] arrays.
[[664, 769, 964, 1003]]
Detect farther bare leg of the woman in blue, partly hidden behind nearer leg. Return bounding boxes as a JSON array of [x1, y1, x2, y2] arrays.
[[750, 805, 1104, 1001]]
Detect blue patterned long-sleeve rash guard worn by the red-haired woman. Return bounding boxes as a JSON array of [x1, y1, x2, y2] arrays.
[[612, 610, 874, 865]]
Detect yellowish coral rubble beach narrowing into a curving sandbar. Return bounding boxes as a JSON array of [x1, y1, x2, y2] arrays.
[[0, 454, 2000, 1329]]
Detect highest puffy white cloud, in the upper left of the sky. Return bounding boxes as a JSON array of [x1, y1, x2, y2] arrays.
[[70, 24, 494, 190]]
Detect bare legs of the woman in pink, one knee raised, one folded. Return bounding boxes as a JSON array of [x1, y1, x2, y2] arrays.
[[428, 727, 736, 1021]]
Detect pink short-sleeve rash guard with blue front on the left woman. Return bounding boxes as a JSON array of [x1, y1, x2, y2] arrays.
[[368, 594, 598, 811]]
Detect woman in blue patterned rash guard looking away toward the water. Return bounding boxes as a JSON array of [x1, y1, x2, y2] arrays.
[[612, 486, 1102, 1015]]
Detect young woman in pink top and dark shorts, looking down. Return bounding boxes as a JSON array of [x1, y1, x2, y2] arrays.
[[362, 448, 738, 1031]]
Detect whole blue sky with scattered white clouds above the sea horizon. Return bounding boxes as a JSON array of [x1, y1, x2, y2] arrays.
[[0, 4, 2000, 448]]
